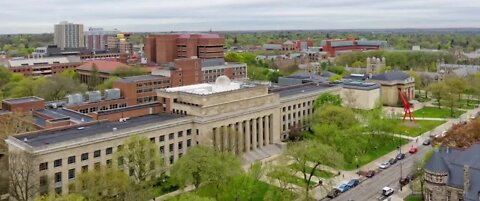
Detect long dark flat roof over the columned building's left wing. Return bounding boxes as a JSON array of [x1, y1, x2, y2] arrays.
[[14, 113, 184, 147]]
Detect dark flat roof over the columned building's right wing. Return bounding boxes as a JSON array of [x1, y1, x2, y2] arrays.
[[270, 83, 334, 98]]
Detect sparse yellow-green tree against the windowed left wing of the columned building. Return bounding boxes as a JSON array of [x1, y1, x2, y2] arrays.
[[115, 135, 165, 184]]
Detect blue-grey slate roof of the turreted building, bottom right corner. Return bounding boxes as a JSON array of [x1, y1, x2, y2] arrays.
[[425, 144, 480, 201]]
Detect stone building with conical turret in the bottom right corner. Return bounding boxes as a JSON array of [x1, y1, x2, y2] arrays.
[[424, 144, 480, 201]]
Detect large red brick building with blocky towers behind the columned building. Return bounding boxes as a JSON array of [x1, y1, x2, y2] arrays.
[[144, 34, 225, 64]]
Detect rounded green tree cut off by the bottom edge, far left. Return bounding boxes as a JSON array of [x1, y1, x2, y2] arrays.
[[73, 167, 131, 201]]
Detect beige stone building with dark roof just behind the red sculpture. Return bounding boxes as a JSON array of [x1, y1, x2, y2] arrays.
[[368, 71, 415, 106]]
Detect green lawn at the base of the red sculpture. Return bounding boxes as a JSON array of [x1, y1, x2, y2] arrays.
[[394, 120, 446, 137]]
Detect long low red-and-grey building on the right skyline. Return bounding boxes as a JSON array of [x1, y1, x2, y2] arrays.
[[320, 38, 387, 57]]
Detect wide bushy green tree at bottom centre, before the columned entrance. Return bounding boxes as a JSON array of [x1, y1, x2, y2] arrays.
[[170, 145, 243, 196]]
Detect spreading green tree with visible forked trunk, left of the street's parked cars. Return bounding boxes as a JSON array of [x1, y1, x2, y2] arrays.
[[285, 141, 343, 198]]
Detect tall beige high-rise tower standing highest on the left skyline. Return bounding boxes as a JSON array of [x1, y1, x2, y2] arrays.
[[54, 21, 85, 50]]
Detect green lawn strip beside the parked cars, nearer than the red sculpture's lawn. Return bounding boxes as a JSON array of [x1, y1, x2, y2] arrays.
[[343, 137, 408, 170]]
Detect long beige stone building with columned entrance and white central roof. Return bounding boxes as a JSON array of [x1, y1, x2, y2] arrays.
[[6, 76, 339, 197]]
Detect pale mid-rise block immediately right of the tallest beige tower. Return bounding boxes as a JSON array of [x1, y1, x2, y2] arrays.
[[85, 27, 120, 51]]
